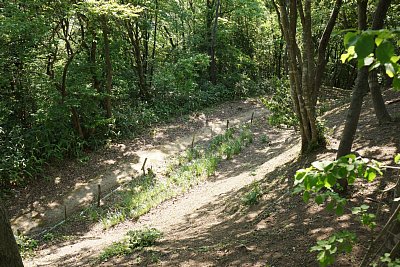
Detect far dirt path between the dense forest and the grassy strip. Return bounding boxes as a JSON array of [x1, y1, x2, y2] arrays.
[[11, 101, 266, 233]]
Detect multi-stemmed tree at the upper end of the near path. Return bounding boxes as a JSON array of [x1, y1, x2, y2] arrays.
[[273, 0, 342, 153]]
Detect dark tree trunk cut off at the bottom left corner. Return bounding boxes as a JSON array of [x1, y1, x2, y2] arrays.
[[0, 200, 24, 267]]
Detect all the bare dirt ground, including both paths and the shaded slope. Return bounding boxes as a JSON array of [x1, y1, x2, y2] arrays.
[[4, 91, 400, 266]]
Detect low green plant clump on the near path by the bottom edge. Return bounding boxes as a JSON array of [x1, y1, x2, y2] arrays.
[[99, 228, 162, 262]]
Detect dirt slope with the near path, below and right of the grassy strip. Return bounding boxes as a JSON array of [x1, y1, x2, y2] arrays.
[[14, 89, 400, 266]]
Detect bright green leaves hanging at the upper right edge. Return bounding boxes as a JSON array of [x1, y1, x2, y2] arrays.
[[341, 30, 400, 89]]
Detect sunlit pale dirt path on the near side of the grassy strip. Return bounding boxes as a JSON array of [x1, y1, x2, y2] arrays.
[[25, 113, 299, 266]]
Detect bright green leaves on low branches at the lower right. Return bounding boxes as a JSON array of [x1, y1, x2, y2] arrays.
[[294, 154, 382, 266]]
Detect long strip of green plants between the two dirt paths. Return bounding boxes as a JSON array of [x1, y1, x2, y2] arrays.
[[84, 126, 253, 229]]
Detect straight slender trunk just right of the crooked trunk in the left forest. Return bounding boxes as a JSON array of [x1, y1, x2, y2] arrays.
[[101, 16, 112, 118]]
